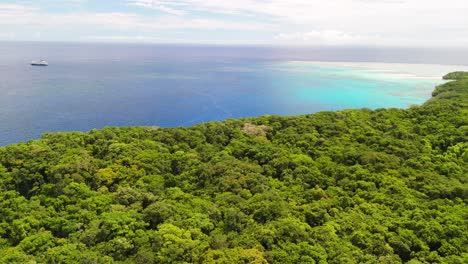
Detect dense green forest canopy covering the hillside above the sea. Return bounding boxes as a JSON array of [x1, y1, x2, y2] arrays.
[[0, 73, 468, 264]]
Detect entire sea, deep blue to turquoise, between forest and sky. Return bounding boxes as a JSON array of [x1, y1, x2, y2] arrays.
[[0, 42, 468, 146]]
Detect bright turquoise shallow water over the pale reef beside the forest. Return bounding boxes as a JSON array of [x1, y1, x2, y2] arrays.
[[268, 62, 442, 110]]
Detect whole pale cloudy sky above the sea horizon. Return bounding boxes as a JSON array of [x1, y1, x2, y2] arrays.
[[0, 0, 468, 47]]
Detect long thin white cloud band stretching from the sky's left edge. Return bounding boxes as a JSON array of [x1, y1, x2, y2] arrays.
[[0, 5, 268, 31]]
